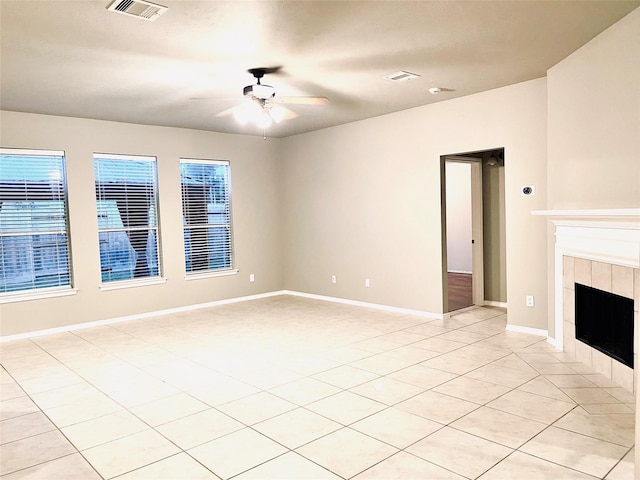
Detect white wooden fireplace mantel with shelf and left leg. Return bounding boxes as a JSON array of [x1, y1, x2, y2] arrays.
[[531, 208, 640, 349]]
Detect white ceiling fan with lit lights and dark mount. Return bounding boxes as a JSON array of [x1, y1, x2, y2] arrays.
[[216, 67, 329, 129]]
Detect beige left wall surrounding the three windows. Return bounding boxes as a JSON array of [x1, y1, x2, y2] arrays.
[[0, 112, 283, 336]]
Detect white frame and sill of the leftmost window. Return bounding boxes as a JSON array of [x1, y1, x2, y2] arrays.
[[0, 147, 77, 304]]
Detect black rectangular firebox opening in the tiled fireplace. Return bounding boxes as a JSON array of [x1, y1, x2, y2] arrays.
[[575, 283, 633, 368]]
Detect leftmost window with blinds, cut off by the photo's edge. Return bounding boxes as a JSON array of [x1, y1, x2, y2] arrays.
[[0, 148, 71, 294]]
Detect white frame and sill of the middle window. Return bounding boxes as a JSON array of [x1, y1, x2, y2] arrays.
[[93, 152, 166, 291]]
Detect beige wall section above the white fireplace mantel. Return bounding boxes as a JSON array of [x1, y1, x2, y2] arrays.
[[547, 9, 640, 209]]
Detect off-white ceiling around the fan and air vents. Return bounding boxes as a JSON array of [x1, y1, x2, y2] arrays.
[[0, 0, 640, 137]]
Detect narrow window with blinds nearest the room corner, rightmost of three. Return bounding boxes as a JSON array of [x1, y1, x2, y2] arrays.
[[180, 159, 233, 274]]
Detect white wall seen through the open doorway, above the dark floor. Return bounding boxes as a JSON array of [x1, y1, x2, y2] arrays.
[[445, 162, 473, 273]]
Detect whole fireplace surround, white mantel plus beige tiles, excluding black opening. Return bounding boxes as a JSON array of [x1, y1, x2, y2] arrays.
[[532, 209, 640, 392]]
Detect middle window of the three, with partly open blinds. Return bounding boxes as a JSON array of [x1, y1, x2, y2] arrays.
[[93, 154, 160, 283]]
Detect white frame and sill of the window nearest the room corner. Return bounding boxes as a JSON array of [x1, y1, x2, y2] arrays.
[[180, 157, 238, 280]]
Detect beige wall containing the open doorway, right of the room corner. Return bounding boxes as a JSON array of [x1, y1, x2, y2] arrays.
[[282, 79, 547, 329]]
